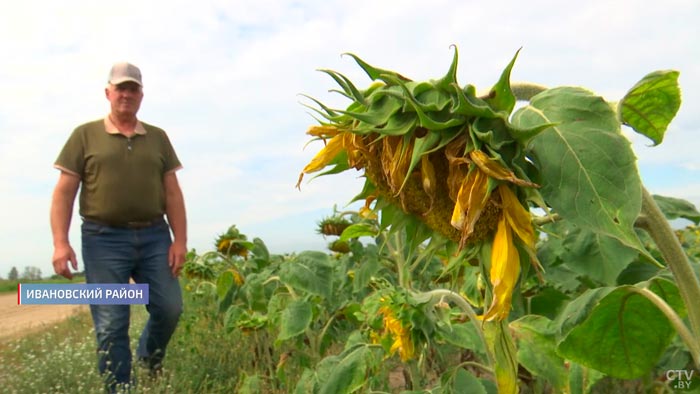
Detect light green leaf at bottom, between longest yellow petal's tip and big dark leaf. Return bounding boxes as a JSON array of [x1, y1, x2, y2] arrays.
[[510, 315, 569, 392]]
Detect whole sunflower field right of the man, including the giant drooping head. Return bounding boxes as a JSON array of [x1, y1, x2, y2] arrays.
[[185, 48, 700, 394]]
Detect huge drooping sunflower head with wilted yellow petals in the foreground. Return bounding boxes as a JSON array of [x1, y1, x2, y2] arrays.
[[297, 49, 550, 322]]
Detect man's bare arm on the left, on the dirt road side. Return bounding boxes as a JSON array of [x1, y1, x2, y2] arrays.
[[50, 171, 80, 279]]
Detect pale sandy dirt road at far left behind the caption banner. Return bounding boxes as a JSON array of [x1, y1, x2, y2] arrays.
[[0, 293, 89, 340]]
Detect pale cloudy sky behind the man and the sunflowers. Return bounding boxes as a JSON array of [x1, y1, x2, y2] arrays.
[[0, 0, 700, 277]]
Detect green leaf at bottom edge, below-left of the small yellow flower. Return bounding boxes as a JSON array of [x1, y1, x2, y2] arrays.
[[319, 344, 371, 394]]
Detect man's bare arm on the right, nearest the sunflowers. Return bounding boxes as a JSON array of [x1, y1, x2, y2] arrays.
[[163, 171, 187, 276]]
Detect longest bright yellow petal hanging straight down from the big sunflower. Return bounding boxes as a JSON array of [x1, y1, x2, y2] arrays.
[[484, 217, 520, 321]]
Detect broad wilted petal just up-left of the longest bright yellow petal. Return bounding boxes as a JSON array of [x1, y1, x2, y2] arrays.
[[450, 168, 490, 238]]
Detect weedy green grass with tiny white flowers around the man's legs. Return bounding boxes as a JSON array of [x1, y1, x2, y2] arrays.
[[0, 282, 255, 394]]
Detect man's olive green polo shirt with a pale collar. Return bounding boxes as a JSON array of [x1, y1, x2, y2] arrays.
[[54, 117, 181, 224]]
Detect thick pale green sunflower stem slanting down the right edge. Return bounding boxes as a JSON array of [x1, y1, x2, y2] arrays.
[[636, 188, 700, 354]]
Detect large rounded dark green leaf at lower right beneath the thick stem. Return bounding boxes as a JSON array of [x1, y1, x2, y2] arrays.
[[557, 281, 677, 379]]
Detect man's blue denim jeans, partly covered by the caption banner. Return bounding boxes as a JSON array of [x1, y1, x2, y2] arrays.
[[82, 221, 182, 384]]
